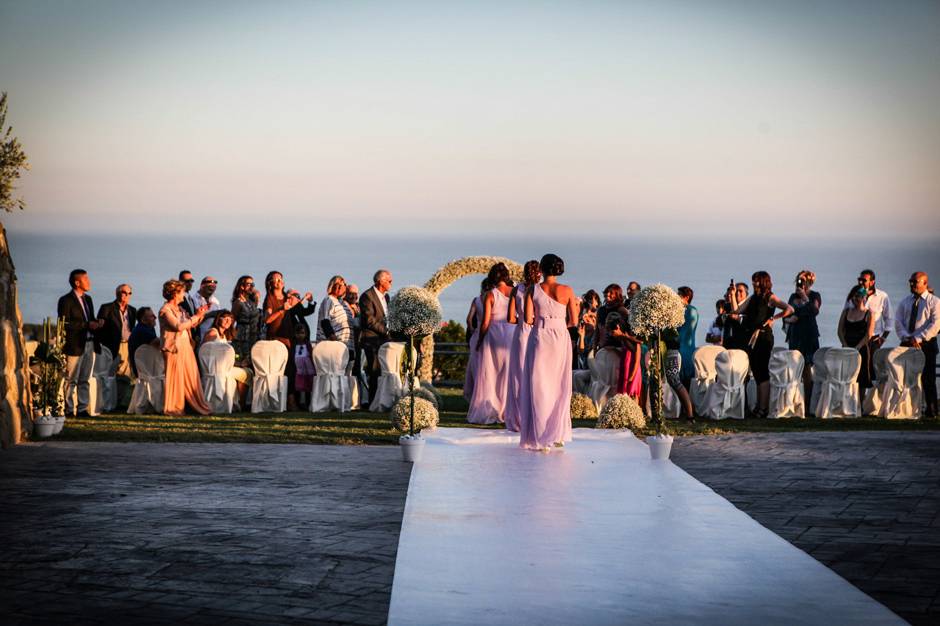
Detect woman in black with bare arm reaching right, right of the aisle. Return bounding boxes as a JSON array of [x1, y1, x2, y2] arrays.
[[735, 271, 793, 418]]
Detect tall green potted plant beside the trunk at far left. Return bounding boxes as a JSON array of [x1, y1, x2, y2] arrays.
[[33, 318, 65, 437]]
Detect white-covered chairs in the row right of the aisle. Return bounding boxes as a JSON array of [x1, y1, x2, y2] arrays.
[[574, 345, 925, 419]]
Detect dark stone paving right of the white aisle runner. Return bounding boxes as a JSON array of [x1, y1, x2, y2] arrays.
[[672, 432, 940, 625]]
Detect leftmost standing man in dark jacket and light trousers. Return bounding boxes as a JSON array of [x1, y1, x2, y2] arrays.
[[58, 269, 103, 416]]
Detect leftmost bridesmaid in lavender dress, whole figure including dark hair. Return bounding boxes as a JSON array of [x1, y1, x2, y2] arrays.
[[467, 263, 513, 424]]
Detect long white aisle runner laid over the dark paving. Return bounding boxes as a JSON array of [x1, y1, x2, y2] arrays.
[[389, 428, 904, 626]]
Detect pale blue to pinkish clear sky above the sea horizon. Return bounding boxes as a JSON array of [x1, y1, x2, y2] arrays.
[[0, 0, 940, 240]]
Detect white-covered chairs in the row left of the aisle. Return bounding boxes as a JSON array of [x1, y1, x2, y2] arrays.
[[126, 341, 416, 414]]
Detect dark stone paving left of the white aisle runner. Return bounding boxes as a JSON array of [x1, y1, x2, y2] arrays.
[[0, 442, 411, 624]]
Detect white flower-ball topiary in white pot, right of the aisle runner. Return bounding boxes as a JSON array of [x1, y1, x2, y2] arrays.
[[630, 284, 685, 460]]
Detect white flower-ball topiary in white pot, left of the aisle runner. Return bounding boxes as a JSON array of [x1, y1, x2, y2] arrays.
[[388, 286, 441, 462]]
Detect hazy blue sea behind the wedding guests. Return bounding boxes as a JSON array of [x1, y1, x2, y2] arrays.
[[7, 231, 940, 345]]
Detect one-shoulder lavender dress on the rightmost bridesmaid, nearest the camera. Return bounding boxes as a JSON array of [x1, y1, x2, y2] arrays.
[[519, 285, 571, 450]]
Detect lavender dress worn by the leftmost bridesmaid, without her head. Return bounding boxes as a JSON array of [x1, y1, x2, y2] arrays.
[[467, 288, 513, 424]]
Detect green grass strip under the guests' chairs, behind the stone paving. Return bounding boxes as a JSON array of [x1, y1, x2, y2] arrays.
[[55, 389, 940, 445]]
